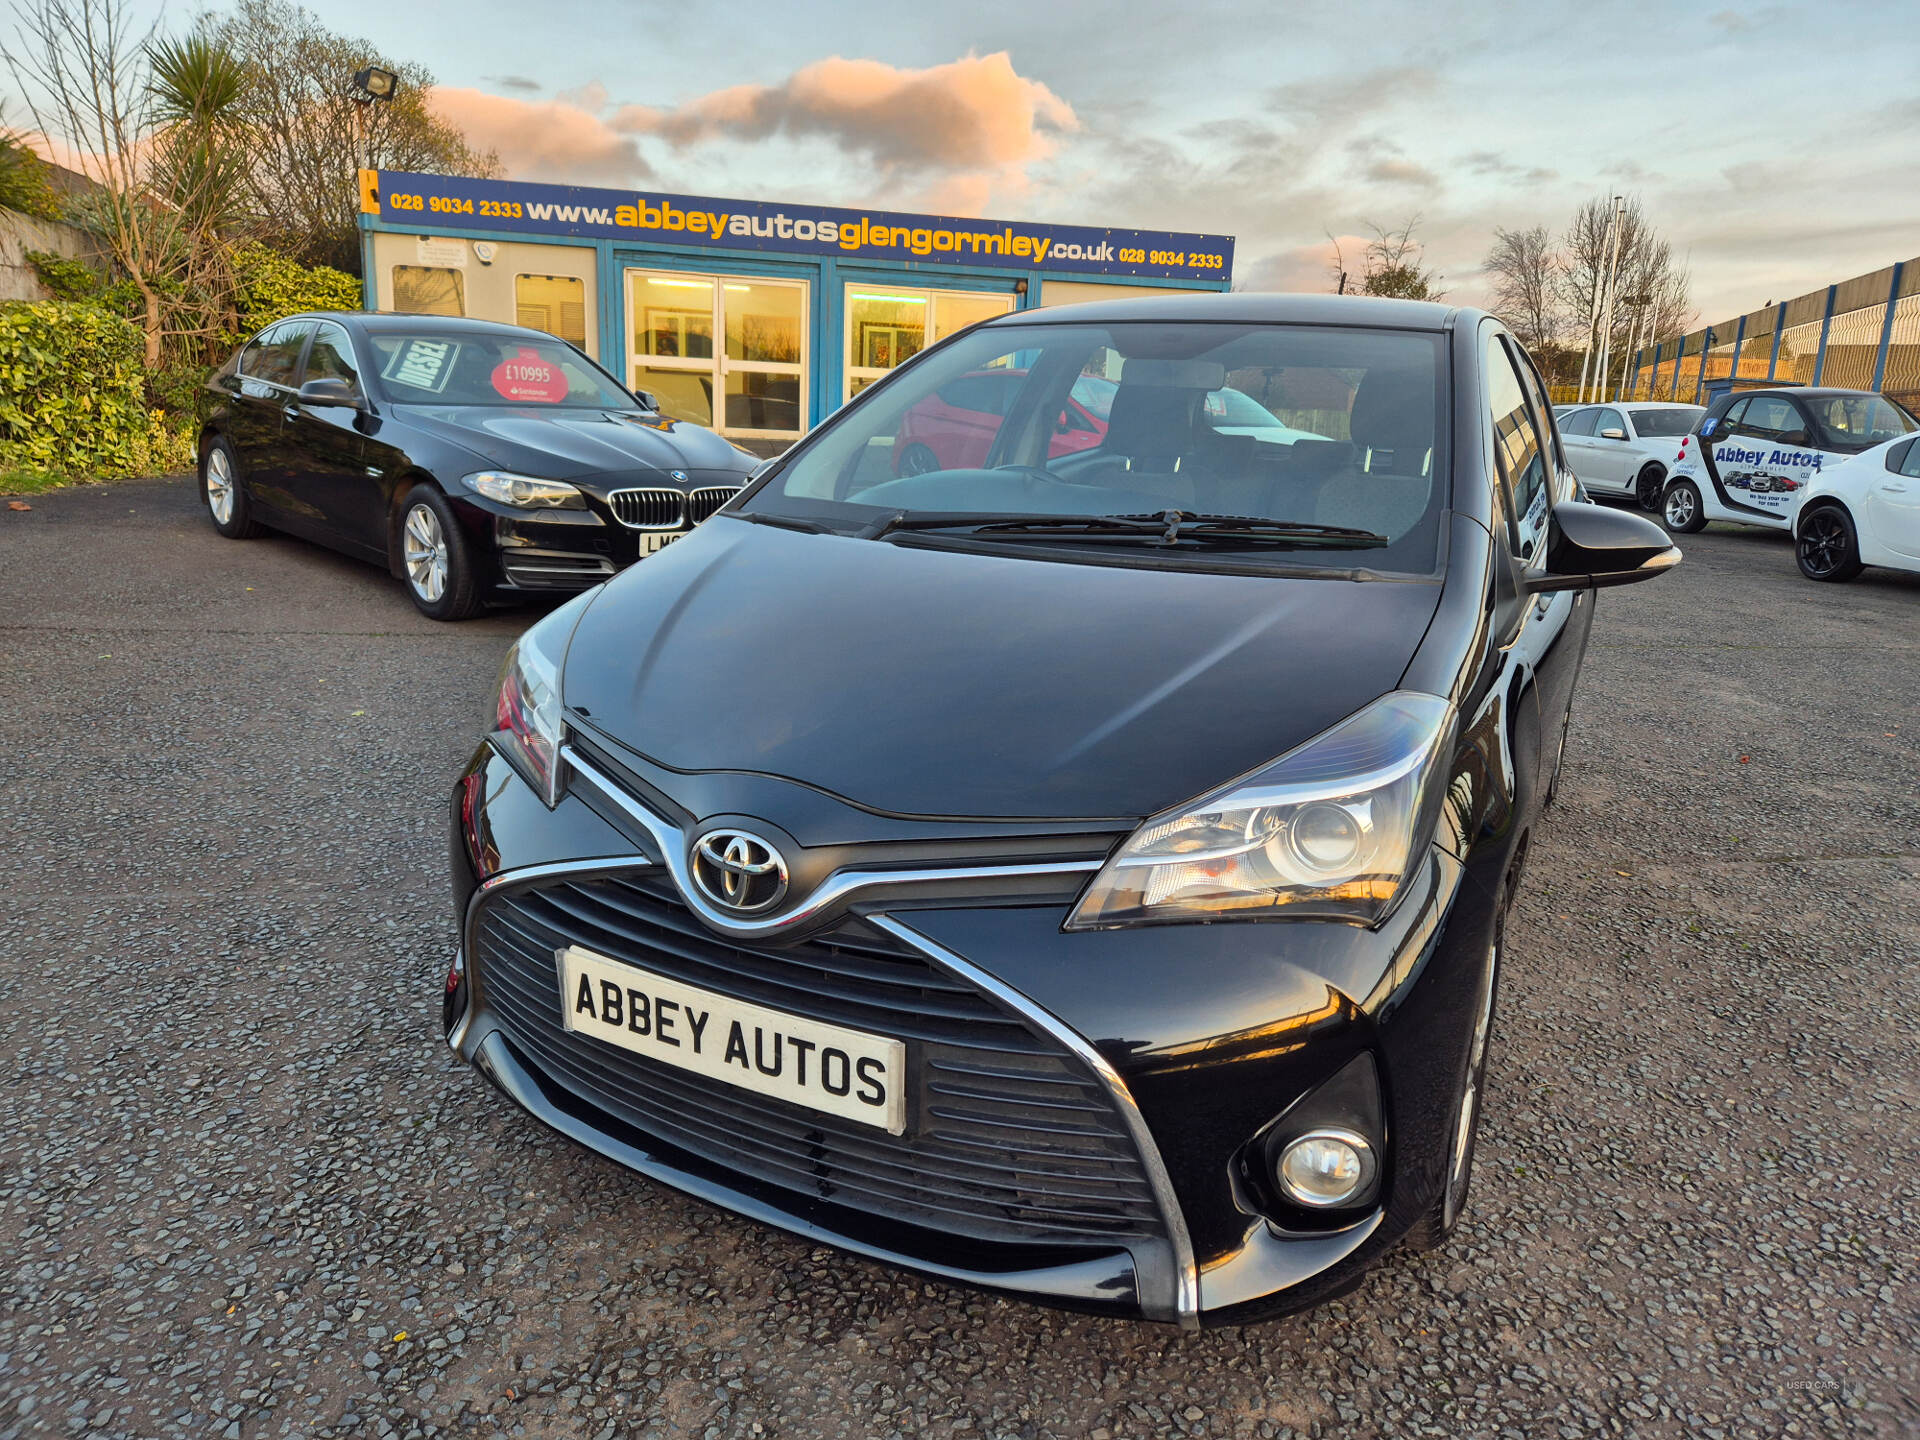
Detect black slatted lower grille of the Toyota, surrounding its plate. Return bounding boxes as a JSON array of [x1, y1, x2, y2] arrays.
[[472, 874, 1165, 1244]]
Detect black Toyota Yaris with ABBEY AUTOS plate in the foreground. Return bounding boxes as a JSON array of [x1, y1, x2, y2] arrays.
[[444, 296, 1680, 1325]]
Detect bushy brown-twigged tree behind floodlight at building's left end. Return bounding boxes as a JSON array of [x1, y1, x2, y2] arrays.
[[205, 0, 499, 275]]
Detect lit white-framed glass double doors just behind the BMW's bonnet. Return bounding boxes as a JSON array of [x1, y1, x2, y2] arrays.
[[626, 271, 808, 449]]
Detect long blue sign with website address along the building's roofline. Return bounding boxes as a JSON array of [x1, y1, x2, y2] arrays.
[[361, 171, 1233, 280]]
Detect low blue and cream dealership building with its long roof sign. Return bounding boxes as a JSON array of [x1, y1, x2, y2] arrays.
[[361, 171, 1233, 455]]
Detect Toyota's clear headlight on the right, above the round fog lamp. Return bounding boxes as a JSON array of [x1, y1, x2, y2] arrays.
[[1068, 691, 1455, 929]]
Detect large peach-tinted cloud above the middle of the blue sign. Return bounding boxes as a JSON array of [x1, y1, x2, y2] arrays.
[[611, 50, 1079, 200]]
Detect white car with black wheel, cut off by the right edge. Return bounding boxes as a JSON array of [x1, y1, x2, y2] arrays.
[[1793, 436, 1920, 580]]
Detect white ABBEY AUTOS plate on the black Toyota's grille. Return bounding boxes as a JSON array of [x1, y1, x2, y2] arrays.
[[557, 945, 906, 1135]]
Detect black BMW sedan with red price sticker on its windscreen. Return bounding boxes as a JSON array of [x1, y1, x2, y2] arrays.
[[200, 313, 758, 620]]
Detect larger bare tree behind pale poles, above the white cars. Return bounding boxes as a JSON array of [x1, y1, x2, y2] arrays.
[[1555, 196, 1693, 397]]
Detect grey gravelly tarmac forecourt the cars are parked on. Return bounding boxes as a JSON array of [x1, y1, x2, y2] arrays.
[[0, 482, 1920, 1440]]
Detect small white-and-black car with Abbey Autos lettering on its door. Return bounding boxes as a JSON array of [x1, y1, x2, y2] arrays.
[[1661, 388, 1920, 536]]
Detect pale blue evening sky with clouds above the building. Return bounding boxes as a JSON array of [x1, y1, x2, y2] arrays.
[[10, 0, 1920, 323]]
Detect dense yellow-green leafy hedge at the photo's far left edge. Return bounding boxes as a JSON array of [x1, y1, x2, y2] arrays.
[[0, 300, 190, 480]]
